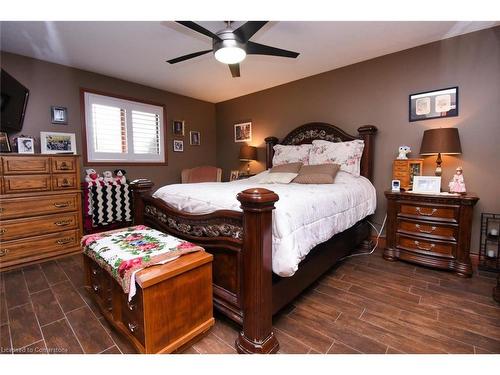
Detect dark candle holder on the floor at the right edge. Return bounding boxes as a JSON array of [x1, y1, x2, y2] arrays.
[[478, 212, 500, 272]]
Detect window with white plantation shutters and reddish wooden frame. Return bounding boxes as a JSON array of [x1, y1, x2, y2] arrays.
[[82, 91, 166, 164]]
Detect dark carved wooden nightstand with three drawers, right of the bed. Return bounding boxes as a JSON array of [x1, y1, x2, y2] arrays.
[[384, 191, 479, 277]]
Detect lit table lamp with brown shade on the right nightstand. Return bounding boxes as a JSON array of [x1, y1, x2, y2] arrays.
[[420, 128, 462, 176]]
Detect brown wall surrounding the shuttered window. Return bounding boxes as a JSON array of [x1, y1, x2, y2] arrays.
[[0, 52, 216, 186]]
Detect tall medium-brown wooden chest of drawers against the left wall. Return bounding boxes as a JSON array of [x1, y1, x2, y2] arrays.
[[0, 154, 82, 271]]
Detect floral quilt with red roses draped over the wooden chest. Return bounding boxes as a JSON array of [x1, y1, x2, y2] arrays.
[[81, 225, 203, 299]]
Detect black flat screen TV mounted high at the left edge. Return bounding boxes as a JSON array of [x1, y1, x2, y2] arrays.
[[0, 69, 29, 132]]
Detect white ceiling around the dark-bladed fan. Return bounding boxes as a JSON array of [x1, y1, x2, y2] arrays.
[[0, 21, 500, 103]]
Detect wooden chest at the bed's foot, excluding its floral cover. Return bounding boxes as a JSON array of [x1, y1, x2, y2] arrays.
[[84, 252, 214, 354]]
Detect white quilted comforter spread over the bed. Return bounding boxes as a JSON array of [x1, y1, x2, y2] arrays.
[[153, 171, 376, 276]]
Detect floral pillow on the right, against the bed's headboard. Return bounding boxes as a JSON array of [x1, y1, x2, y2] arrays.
[[309, 139, 365, 176]]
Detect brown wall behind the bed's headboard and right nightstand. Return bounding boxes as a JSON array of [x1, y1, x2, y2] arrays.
[[216, 27, 500, 252]]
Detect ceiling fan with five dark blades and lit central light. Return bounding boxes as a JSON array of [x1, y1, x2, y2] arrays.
[[167, 21, 299, 77]]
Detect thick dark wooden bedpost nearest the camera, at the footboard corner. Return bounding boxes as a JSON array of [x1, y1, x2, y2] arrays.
[[236, 188, 279, 354]]
